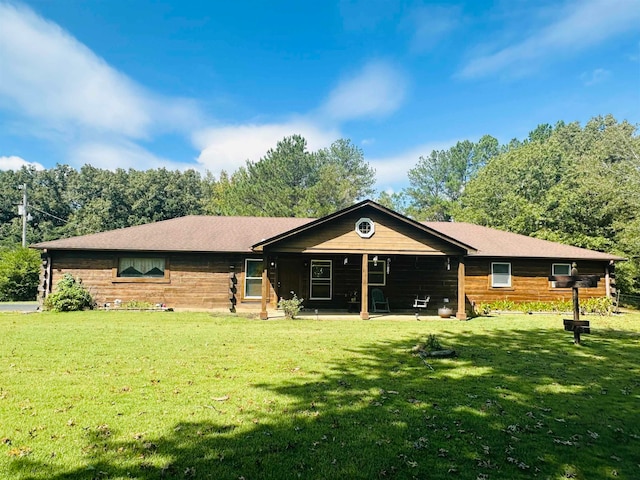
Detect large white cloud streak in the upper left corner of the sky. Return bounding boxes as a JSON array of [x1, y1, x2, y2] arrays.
[[0, 3, 198, 138]]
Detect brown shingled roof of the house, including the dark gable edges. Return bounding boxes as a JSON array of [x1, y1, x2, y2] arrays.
[[32, 200, 624, 261]]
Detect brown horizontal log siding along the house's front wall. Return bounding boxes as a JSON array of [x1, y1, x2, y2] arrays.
[[47, 249, 606, 313]]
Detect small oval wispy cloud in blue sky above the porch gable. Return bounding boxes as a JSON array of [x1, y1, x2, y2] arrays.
[[321, 61, 407, 121]]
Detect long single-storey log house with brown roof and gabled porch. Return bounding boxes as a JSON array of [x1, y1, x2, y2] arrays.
[[32, 200, 623, 319]]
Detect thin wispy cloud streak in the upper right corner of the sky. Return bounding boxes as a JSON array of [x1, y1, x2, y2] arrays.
[[460, 0, 640, 78]]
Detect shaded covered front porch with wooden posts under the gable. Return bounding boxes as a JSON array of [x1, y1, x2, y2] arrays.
[[261, 252, 467, 320]]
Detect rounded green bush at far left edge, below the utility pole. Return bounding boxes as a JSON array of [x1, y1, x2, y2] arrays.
[[0, 248, 40, 302]]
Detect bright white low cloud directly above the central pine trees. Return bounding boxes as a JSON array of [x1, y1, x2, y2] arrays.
[[193, 119, 340, 174]]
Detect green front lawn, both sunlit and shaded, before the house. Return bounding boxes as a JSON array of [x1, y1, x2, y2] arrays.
[[0, 312, 640, 480]]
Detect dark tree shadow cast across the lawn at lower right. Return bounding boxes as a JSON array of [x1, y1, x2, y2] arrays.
[[12, 329, 640, 480]]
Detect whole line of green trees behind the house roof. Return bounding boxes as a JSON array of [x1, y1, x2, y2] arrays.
[[0, 115, 640, 296]]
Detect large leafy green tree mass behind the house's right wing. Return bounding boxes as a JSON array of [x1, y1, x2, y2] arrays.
[[455, 115, 640, 293]]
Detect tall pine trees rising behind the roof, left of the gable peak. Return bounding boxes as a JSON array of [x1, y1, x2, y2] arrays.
[[212, 135, 375, 217]]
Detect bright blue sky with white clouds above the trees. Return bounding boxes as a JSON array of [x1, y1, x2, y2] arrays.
[[0, 0, 640, 191]]
